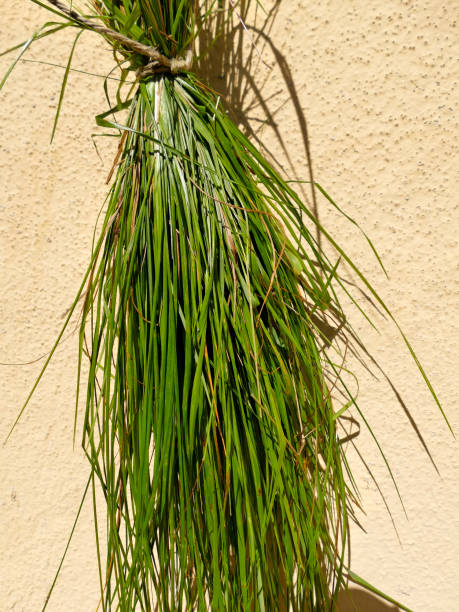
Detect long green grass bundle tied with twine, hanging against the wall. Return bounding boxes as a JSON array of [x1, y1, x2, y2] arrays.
[[2, 0, 452, 612]]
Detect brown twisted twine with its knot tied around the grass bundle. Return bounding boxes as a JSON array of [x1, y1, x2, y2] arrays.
[[47, 0, 193, 80]]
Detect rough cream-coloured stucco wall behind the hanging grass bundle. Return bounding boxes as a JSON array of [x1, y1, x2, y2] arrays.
[[0, 0, 459, 612]]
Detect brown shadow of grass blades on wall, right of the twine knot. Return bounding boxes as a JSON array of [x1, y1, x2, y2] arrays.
[[198, 0, 321, 247]]
